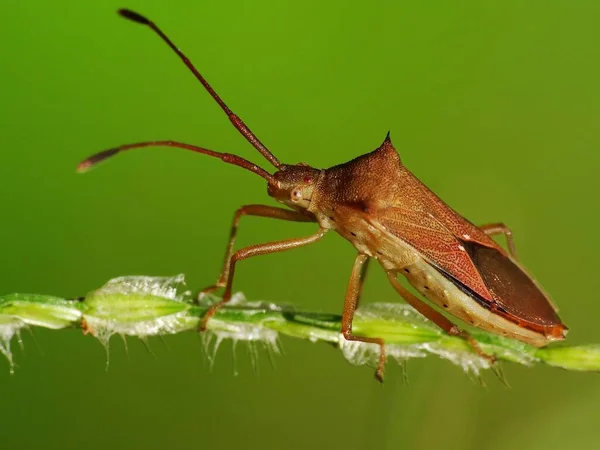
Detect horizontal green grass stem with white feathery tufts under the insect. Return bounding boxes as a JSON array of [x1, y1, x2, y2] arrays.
[[0, 276, 600, 374]]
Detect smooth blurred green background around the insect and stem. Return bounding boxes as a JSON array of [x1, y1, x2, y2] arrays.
[[0, 0, 600, 450]]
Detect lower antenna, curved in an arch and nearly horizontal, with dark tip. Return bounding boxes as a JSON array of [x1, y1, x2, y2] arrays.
[[77, 141, 275, 183]]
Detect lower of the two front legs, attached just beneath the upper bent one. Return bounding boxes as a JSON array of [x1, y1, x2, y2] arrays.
[[200, 228, 327, 331]]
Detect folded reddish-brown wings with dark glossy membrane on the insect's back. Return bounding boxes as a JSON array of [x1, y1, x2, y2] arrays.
[[372, 167, 564, 334]]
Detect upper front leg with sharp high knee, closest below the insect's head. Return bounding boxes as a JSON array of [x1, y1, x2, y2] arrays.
[[201, 205, 314, 295]]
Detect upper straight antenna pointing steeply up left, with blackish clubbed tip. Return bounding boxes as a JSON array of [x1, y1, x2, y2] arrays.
[[119, 9, 281, 169]]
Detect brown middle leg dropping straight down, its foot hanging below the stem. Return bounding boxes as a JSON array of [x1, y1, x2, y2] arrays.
[[342, 254, 385, 382]]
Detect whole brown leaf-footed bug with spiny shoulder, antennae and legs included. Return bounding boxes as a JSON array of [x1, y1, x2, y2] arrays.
[[78, 9, 567, 380]]
